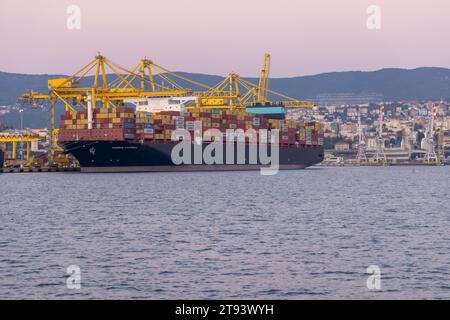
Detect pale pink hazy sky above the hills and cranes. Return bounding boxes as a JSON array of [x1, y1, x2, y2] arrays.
[[0, 0, 450, 77]]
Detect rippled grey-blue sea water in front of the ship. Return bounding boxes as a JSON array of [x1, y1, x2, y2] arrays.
[[0, 167, 450, 299]]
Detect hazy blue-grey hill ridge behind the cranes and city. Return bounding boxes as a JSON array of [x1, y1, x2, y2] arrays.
[[0, 68, 450, 127]]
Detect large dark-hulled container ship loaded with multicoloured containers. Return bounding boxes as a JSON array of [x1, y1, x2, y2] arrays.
[[58, 103, 324, 173]]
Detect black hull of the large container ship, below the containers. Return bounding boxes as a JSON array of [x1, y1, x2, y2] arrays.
[[60, 141, 324, 172]]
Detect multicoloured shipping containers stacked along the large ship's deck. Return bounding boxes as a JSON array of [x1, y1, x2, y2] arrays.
[[58, 108, 323, 145]]
